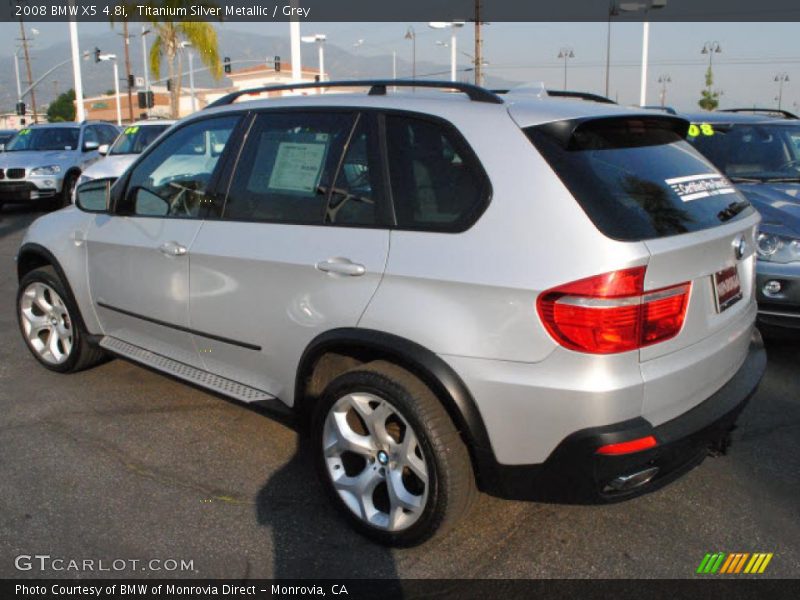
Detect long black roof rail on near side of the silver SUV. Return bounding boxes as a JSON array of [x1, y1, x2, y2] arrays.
[[206, 79, 503, 108]]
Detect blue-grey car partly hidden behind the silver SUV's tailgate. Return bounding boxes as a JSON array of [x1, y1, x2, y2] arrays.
[[688, 112, 800, 329]]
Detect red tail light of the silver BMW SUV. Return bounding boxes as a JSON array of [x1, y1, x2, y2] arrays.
[[536, 267, 691, 354]]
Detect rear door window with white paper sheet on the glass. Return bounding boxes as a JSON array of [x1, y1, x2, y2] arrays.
[[223, 112, 380, 226]]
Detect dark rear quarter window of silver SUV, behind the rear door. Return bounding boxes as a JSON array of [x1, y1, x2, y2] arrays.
[[386, 115, 489, 231]]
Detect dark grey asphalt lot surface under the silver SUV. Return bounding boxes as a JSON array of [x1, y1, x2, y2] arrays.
[[0, 206, 800, 578]]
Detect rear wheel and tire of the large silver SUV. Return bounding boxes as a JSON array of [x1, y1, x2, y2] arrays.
[[312, 362, 476, 546]]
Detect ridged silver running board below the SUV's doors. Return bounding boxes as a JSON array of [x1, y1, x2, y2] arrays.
[[100, 336, 286, 409]]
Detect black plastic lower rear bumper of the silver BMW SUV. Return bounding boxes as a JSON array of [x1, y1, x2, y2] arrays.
[[481, 331, 766, 504]]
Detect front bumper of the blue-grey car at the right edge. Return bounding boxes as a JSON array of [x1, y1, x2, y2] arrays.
[[756, 260, 800, 329]]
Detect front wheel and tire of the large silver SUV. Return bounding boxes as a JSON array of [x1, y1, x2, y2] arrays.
[[17, 266, 105, 373]]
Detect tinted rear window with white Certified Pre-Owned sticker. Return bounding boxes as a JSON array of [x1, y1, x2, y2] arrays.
[[525, 117, 753, 241]]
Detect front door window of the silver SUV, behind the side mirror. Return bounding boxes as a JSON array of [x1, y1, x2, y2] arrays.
[[117, 115, 240, 218]]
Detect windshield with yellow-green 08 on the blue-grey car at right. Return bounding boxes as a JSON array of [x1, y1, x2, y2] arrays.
[[687, 123, 800, 181]]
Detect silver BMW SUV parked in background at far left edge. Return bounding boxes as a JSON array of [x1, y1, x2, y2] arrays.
[[0, 121, 119, 207]]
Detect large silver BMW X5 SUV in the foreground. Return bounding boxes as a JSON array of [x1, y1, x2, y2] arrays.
[[18, 82, 766, 545]]
